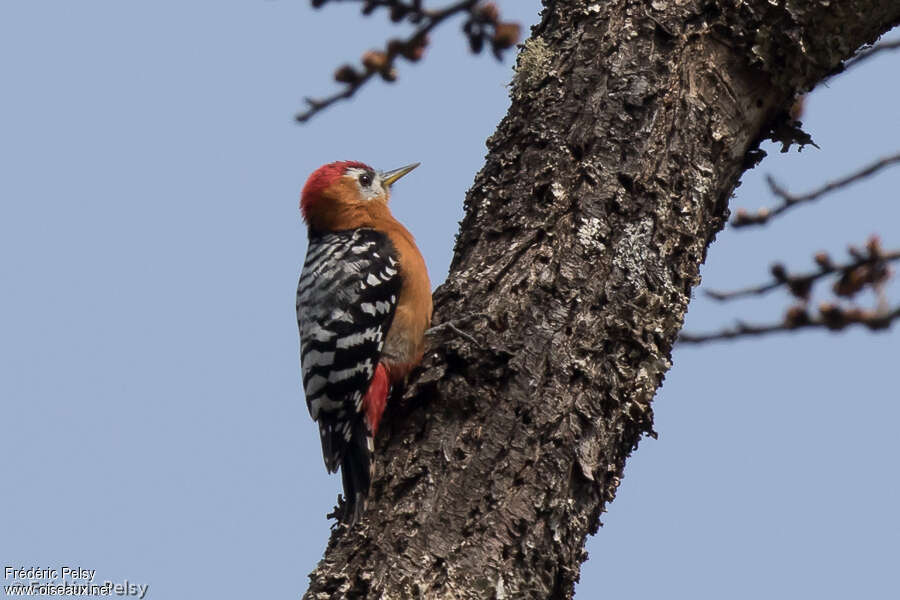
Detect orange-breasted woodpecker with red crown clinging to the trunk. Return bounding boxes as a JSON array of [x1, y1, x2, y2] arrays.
[[297, 161, 432, 525]]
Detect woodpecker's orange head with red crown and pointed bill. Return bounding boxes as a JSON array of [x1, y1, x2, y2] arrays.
[[300, 161, 419, 231]]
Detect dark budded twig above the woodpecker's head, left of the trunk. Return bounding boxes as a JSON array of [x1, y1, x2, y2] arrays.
[[295, 0, 520, 123]]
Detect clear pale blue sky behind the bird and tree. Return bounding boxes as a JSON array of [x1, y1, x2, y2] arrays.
[[0, 0, 900, 600]]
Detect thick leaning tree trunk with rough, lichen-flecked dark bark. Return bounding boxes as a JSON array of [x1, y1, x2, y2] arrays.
[[306, 0, 900, 599]]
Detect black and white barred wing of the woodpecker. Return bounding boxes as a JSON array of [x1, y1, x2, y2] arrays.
[[297, 229, 400, 472]]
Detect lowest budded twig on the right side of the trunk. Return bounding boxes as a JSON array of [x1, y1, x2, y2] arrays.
[[678, 303, 900, 344]]
